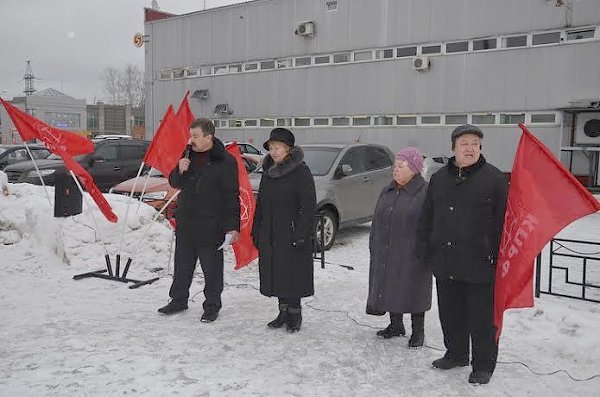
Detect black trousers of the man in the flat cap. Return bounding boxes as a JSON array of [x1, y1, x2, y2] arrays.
[[436, 280, 498, 372]]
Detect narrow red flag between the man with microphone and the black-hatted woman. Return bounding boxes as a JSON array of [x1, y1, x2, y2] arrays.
[[227, 142, 258, 270]]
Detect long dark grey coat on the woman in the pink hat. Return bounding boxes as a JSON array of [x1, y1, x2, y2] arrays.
[[367, 175, 432, 314]]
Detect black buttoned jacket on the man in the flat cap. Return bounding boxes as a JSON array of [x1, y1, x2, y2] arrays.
[[418, 156, 508, 283]]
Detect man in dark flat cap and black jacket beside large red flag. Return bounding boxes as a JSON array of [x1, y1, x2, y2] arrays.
[[418, 124, 508, 384]]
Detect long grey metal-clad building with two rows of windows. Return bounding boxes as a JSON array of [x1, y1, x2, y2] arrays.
[[144, 0, 600, 186]]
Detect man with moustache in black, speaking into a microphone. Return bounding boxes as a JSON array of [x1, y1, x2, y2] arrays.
[[158, 118, 240, 322]]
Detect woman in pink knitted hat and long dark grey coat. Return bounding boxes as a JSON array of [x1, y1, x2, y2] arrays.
[[367, 148, 432, 347]]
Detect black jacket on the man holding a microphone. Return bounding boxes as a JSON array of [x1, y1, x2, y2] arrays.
[[169, 138, 240, 245]]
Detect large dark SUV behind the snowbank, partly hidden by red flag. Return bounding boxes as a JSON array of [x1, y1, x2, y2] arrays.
[[4, 139, 150, 191]]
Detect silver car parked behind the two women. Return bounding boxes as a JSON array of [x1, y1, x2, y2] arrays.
[[250, 143, 394, 249]]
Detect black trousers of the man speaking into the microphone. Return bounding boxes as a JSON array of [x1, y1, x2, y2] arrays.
[[169, 234, 223, 311]]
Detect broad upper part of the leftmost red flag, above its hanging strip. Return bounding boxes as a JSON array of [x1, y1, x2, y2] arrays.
[[0, 98, 94, 156]]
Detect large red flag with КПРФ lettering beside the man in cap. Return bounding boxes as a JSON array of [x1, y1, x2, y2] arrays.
[[494, 124, 600, 339]]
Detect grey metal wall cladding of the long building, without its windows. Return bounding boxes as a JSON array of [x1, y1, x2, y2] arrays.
[[146, 0, 600, 171]]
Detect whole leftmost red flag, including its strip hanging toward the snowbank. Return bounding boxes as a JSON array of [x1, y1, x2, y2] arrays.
[[0, 98, 117, 222]]
